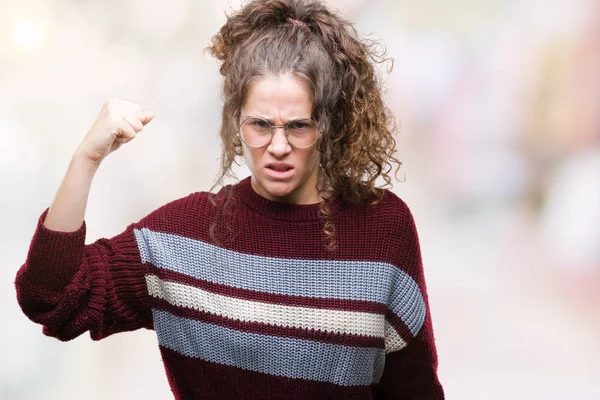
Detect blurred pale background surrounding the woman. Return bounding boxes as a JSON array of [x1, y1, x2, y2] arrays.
[[0, 0, 600, 400]]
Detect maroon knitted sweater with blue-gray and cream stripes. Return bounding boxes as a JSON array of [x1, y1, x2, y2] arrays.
[[15, 178, 444, 400]]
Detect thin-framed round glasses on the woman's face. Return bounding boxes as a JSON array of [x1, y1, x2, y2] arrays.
[[238, 117, 319, 148]]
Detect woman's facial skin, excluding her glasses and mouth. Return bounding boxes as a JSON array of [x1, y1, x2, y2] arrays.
[[241, 74, 322, 204]]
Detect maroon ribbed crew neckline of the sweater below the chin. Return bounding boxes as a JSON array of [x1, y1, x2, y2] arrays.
[[235, 176, 340, 221]]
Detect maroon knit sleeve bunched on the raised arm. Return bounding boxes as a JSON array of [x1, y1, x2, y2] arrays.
[[14, 209, 158, 341]]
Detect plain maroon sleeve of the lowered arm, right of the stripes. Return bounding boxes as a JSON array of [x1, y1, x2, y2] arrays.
[[375, 204, 445, 400]]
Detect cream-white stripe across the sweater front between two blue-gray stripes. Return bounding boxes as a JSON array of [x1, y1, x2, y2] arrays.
[[146, 275, 385, 338]]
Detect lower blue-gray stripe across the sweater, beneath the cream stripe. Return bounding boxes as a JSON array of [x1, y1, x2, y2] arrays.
[[153, 310, 385, 386]]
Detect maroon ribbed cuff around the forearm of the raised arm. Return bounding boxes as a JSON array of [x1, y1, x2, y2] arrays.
[[23, 208, 86, 290]]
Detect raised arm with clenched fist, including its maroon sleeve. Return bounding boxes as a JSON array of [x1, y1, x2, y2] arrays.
[[15, 99, 158, 340]]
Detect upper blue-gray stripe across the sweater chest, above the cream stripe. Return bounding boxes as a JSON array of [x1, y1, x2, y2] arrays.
[[134, 228, 425, 335]]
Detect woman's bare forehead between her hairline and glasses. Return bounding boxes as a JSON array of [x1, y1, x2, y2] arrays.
[[242, 74, 313, 117]]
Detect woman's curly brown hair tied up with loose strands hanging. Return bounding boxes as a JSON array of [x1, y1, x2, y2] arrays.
[[207, 0, 401, 249]]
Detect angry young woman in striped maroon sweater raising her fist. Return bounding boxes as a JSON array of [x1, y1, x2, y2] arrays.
[[15, 0, 444, 400]]
